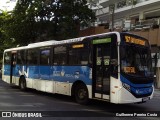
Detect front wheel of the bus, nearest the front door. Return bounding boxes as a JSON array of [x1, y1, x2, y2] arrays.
[[75, 83, 89, 105]]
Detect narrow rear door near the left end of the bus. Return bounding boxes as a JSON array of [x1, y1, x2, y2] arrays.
[[10, 51, 17, 83]]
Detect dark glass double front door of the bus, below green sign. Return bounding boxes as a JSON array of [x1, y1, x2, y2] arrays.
[[93, 43, 111, 100]]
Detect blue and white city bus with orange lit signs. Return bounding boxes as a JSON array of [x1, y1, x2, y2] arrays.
[[2, 32, 154, 104]]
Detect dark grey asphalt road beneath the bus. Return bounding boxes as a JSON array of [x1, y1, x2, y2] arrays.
[[0, 80, 160, 120]]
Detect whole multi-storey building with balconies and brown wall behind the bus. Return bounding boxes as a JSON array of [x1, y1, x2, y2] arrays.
[[85, 0, 160, 88]]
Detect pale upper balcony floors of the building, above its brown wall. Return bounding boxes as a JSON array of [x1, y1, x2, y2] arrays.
[[88, 0, 160, 30]]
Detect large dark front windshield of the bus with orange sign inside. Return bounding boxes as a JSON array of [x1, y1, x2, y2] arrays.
[[120, 40, 153, 77]]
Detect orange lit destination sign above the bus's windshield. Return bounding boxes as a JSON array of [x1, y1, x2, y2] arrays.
[[125, 36, 145, 46]]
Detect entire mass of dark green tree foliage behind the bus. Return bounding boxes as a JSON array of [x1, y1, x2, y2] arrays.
[[0, 0, 95, 47]]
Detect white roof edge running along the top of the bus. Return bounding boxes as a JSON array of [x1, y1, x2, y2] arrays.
[[5, 32, 119, 52]]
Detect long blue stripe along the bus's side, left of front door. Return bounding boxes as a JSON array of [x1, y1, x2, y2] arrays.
[[4, 65, 92, 85]]
